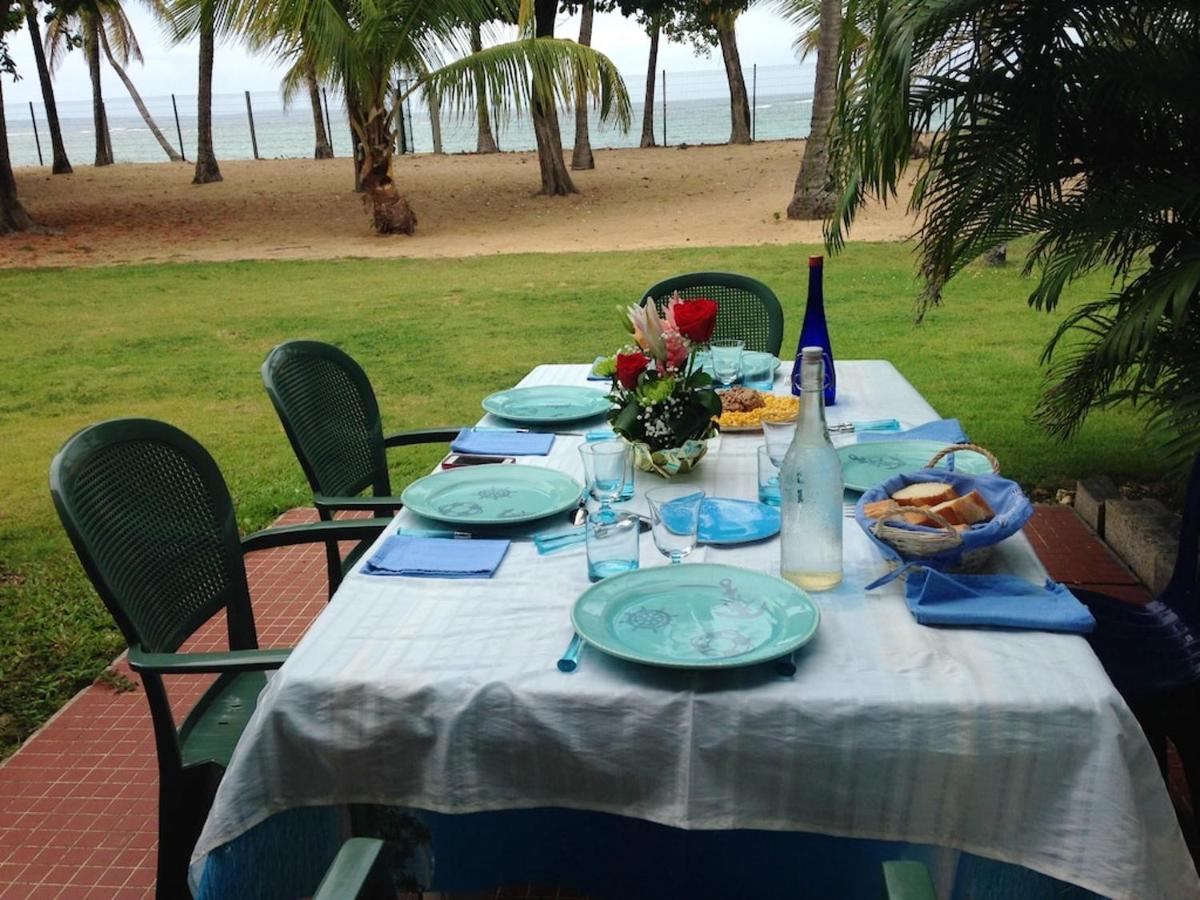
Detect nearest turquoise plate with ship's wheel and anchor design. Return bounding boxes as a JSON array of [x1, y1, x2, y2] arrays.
[[571, 563, 821, 668]]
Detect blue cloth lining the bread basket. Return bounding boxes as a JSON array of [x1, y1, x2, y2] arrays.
[[854, 469, 1033, 569]]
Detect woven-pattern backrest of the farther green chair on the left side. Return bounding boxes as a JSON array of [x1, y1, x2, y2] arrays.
[[263, 341, 391, 497]]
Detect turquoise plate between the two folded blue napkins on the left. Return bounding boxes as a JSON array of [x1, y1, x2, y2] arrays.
[[400, 463, 583, 526]]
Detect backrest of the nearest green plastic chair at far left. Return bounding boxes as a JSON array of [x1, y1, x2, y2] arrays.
[[50, 419, 257, 653]]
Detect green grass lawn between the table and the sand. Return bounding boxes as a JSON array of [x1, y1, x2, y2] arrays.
[[0, 244, 1160, 752]]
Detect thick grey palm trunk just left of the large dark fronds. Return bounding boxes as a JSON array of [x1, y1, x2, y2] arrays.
[[787, 0, 841, 218]]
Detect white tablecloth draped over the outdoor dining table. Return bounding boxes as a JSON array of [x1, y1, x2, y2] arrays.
[[194, 361, 1200, 900]]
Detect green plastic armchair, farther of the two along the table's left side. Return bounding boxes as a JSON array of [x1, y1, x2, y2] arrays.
[[263, 341, 467, 595]]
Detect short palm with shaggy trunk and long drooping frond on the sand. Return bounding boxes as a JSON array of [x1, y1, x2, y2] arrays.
[[229, 0, 629, 234]]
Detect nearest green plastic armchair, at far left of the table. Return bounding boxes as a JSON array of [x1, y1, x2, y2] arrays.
[[50, 419, 386, 898]]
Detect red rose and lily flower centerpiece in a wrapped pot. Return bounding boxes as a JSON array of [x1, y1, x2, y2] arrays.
[[608, 293, 721, 478]]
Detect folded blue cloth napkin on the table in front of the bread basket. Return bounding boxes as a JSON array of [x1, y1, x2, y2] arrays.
[[905, 569, 1096, 635]]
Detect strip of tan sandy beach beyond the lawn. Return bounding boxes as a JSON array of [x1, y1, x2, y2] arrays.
[[0, 140, 913, 266]]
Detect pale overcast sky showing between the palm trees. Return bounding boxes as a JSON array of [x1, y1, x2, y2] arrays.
[[4, 4, 796, 106]]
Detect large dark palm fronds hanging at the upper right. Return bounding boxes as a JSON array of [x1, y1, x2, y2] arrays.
[[828, 0, 1200, 472]]
